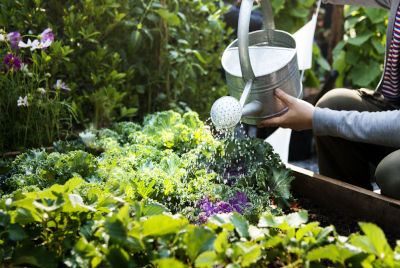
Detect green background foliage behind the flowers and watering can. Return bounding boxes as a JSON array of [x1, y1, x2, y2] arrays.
[[0, 0, 387, 151]]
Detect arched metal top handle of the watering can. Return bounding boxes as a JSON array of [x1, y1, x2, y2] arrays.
[[238, 0, 275, 81]]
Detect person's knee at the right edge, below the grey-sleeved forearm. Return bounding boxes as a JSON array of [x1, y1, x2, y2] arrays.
[[375, 150, 400, 199]]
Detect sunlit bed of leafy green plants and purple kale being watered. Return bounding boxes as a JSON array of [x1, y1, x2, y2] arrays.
[[0, 111, 400, 268]]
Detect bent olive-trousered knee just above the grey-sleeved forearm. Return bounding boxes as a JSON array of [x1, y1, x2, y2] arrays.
[[316, 88, 359, 110]]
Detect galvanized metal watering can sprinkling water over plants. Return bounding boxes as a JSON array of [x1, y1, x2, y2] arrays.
[[210, 0, 302, 128]]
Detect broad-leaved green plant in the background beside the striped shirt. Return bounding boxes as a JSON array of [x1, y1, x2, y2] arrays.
[[333, 6, 389, 89]]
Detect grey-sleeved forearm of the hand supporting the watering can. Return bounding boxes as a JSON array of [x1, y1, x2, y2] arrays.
[[312, 108, 400, 148]]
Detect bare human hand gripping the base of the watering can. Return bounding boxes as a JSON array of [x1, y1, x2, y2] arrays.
[[257, 88, 314, 130]]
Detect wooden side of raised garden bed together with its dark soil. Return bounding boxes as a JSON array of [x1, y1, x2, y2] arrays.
[[287, 164, 400, 246]]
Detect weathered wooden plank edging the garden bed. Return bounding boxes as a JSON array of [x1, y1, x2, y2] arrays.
[[287, 164, 400, 236]]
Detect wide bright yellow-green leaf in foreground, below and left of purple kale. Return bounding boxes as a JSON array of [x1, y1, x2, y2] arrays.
[[142, 215, 187, 237]]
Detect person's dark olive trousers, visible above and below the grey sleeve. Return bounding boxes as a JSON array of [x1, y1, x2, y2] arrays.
[[315, 89, 400, 198]]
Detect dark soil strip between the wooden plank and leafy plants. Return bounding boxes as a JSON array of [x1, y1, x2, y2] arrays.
[[294, 193, 400, 248]]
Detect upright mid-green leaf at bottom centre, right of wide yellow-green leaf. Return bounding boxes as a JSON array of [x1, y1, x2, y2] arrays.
[[183, 226, 215, 261]]
